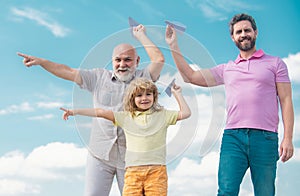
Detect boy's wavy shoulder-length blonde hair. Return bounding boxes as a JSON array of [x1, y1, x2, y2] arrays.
[[123, 78, 162, 116]]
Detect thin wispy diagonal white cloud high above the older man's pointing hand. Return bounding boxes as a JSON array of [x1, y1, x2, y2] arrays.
[[11, 7, 70, 37]]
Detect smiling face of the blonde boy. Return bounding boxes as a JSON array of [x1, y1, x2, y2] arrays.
[[134, 91, 154, 111]]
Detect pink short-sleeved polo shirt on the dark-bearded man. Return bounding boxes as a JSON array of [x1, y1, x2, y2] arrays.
[[210, 50, 290, 132]]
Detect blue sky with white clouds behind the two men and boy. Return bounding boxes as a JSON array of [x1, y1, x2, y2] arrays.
[[0, 0, 300, 196]]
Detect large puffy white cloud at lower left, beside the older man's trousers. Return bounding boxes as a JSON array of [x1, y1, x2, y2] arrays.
[[0, 142, 87, 179]]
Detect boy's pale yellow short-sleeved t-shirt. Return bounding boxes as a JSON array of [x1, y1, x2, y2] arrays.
[[114, 109, 178, 167]]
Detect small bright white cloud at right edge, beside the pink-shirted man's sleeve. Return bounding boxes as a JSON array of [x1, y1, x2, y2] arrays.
[[283, 52, 300, 83]]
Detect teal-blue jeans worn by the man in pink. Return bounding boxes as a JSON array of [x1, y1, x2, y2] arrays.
[[218, 128, 279, 196]]
